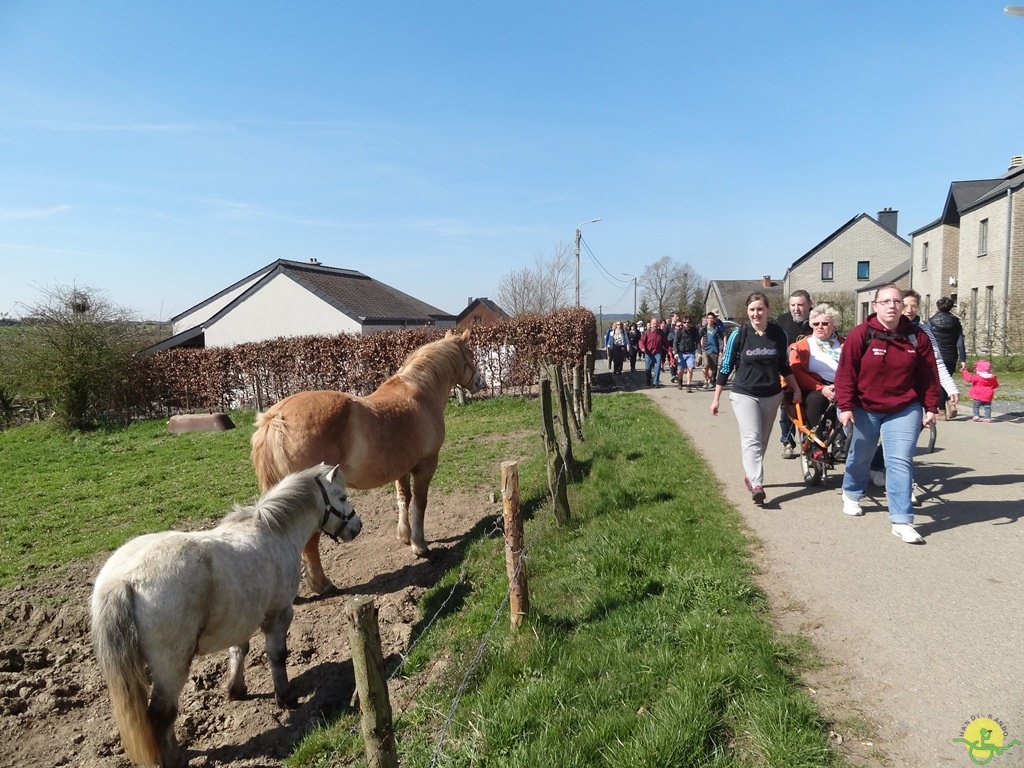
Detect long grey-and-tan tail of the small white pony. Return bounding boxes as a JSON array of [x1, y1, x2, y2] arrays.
[[92, 582, 160, 765]]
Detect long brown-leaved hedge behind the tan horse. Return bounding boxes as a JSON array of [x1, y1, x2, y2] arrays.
[[128, 307, 597, 418]]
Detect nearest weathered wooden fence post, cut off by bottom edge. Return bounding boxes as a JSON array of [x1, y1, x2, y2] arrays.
[[345, 595, 398, 768]]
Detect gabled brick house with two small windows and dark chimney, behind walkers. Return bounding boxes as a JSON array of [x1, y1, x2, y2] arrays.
[[782, 208, 910, 309]]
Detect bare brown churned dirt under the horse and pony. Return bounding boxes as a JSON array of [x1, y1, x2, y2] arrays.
[[0, 488, 501, 768]]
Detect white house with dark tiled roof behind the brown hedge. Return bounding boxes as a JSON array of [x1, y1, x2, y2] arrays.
[[145, 259, 456, 353]]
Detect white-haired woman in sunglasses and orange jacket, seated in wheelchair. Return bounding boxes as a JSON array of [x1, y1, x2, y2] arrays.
[[790, 304, 843, 448]]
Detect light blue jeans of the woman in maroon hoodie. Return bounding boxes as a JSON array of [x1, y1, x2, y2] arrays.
[[843, 402, 923, 524]]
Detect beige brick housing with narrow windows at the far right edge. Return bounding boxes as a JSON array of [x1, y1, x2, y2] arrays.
[[910, 160, 1024, 354]]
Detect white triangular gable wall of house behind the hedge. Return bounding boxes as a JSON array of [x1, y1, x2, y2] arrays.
[[206, 274, 360, 347]]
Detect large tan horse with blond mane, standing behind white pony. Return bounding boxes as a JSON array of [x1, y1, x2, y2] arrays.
[[252, 330, 483, 593]]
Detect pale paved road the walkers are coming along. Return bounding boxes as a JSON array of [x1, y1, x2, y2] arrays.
[[618, 374, 1024, 768]]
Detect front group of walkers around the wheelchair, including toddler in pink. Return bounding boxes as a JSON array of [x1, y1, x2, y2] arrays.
[[711, 285, 998, 544]]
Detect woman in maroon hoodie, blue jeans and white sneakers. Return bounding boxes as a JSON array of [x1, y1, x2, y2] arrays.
[[836, 284, 939, 544]]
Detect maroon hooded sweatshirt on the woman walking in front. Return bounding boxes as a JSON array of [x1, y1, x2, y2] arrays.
[[836, 314, 939, 414]]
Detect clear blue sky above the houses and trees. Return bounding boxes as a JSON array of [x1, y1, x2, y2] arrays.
[[0, 0, 1024, 319]]
